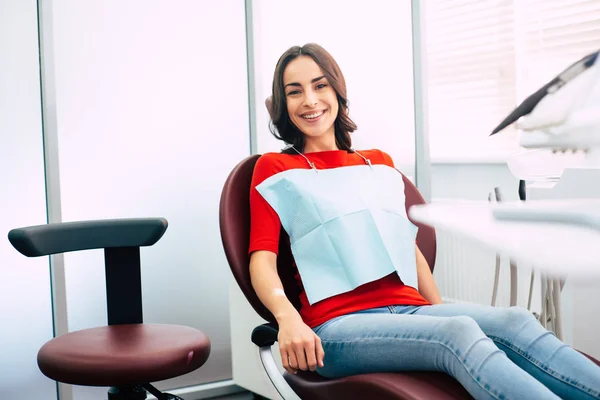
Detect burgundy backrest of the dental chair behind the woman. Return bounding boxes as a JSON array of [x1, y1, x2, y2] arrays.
[[219, 154, 436, 322]]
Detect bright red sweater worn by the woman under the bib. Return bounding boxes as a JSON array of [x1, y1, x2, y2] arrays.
[[249, 150, 430, 328]]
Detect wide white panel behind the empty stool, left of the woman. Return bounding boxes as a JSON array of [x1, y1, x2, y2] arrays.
[[45, 0, 249, 399]]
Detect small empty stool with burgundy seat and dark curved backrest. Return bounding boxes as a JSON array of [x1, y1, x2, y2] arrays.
[[8, 218, 210, 400]]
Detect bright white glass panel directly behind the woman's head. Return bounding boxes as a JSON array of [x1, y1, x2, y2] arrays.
[[253, 0, 415, 175]]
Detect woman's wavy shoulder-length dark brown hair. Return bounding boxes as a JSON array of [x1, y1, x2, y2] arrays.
[[267, 43, 356, 153]]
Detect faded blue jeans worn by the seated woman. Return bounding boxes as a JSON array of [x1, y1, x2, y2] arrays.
[[314, 304, 600, 400]]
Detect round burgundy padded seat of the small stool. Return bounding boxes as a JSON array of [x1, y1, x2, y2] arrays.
[[38, 324, 210, 386]]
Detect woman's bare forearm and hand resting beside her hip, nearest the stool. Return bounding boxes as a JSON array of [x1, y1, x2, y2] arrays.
[[250, 250, 325, 373]]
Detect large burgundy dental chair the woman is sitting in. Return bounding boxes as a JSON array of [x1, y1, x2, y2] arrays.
[[219, 155, 472, 400]]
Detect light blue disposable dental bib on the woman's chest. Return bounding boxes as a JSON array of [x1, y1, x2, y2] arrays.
[[256, 164, 418, 305]]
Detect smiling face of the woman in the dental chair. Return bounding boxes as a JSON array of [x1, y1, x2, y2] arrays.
[[283, 56, 339, 140]]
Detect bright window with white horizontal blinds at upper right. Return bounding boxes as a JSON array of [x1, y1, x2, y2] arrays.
[[423, 0, 600, 161]]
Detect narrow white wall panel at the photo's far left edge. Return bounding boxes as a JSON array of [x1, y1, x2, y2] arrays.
[[0, 0, 56, 400]]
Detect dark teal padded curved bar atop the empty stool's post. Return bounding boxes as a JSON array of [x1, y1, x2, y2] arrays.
[[8, 218, 168, 257]]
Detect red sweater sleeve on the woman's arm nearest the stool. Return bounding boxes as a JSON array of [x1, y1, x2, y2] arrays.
[[248, 154, 284, 254]]
